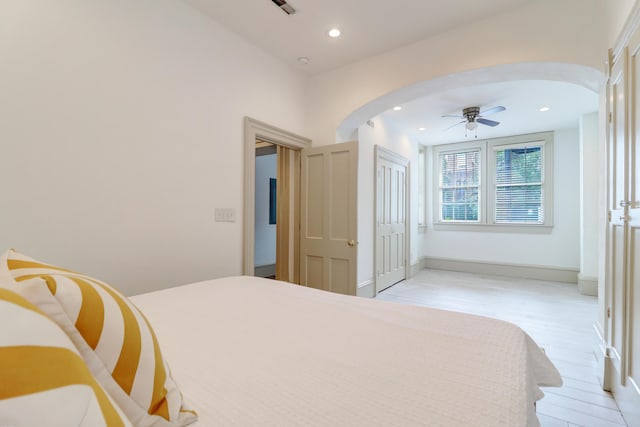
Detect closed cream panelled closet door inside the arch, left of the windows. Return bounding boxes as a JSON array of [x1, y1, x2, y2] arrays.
[[375, 146, 409, 293]]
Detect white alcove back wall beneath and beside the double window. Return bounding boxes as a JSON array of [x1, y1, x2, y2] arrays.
[[421, 129, 580, 271]]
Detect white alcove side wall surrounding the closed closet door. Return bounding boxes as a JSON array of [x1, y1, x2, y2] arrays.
[[358, 116, 419, 285]]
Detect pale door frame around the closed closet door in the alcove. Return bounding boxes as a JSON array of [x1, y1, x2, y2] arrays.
[[373, 145, 411, 295]]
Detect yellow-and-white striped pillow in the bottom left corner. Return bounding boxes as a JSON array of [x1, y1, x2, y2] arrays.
[[0, 288, 131, 427]]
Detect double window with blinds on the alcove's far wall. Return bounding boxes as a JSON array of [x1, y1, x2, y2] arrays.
[[434, 132, 553, 231]]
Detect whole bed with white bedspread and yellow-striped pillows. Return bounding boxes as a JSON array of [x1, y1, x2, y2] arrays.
[[0, 250, 562, 427]]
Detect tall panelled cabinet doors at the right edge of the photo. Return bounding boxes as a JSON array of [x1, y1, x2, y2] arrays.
[[605, 31, 640, 425]]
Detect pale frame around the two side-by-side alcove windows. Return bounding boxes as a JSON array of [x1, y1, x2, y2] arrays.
[[432, 132, 554, 233]]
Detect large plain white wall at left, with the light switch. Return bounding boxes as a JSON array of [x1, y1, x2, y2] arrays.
[[0, 0, 305, 294]]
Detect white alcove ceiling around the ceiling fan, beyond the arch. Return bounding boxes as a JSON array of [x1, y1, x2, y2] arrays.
[[374, 80, 598, 145]]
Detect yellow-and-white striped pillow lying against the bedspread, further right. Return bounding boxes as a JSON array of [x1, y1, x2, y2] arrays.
[[0, 250, 197, 427]]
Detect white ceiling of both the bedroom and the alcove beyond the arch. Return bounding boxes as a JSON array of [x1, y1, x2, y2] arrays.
[[184, 0, 598, 144]]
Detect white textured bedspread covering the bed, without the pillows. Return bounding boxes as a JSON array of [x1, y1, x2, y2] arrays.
[[131, 276, 562, 427]]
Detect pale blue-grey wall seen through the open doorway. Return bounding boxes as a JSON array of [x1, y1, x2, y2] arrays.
[[253, 154, 278, 267]]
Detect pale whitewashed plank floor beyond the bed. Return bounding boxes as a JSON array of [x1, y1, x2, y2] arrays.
[[377, 270, 626, 427]]
